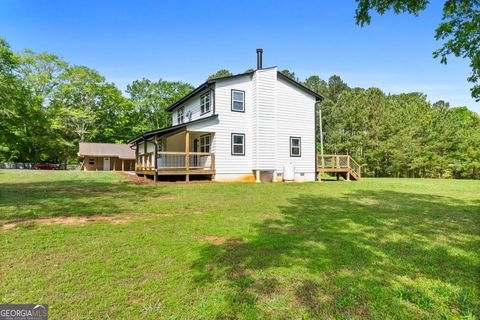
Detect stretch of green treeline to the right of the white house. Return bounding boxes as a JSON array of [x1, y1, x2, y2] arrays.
[[302, 74, 480, 179]]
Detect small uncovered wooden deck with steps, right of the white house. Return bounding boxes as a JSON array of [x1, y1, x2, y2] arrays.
[[317, 154, 361, 181]]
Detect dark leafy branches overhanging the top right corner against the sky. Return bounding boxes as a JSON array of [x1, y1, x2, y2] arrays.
[[355, 0, 480, 101]]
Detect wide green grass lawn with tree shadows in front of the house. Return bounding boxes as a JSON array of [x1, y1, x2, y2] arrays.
[[0, 170, 480, 319]]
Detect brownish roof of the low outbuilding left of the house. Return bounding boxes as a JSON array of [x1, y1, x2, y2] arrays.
[[78, 142, 135, 159]]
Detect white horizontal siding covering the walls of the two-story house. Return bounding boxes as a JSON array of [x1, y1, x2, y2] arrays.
[[171, 68, 316, 180]]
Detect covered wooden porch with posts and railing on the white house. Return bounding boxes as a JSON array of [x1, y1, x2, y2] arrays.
[[135, 128, 215, 181]]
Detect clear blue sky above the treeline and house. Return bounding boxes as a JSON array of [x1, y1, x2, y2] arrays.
[[0, 0, 480, 112]]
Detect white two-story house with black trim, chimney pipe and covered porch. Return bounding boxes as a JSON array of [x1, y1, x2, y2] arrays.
[[131, 49, 322, 181]]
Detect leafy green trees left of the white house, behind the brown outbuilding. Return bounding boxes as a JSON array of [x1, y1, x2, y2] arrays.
[[0, 38, 193, 164]]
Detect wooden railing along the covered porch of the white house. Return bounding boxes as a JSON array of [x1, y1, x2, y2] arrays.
[[137, 151, 215, 172]]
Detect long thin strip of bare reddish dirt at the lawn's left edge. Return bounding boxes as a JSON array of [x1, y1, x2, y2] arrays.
[[1, 216, 137, 230]]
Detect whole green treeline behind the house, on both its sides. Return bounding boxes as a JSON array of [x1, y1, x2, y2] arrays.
[[0, 38, 480, 179]]
